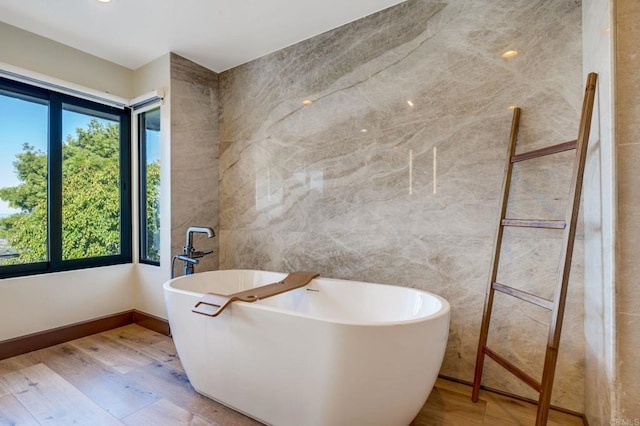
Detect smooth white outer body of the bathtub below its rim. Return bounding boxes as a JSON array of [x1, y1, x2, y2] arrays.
[[165, 273, 449, 426]]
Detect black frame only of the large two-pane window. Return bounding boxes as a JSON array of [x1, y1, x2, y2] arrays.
[[0, 77, 132, 279]]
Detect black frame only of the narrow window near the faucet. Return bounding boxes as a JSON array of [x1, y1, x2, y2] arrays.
[[138, 105, 162, 266]]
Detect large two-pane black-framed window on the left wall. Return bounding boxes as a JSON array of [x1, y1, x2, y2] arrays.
[[0, 79, 131, 277]]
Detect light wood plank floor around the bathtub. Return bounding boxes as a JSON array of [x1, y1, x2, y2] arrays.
[[0, 324, 582, 426]]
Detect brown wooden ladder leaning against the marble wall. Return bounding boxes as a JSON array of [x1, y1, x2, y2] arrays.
[[471, 73, 598, 426]]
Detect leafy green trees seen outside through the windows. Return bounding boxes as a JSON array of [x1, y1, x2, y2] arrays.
[[0, 119, 160, 264]]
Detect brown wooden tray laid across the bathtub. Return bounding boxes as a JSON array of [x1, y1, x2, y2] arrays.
[[192, 272, 320, 317]]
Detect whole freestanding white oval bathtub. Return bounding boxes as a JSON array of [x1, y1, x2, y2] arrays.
[[164, 270, 450, 426]]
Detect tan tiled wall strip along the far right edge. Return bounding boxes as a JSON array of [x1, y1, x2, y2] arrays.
[[616, 0, 640, 422]]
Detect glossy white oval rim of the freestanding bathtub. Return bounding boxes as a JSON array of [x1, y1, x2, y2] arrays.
[[162, 269, 451, 327]]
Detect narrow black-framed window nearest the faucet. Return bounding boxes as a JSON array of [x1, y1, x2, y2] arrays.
[[138, 108, 160, 265]]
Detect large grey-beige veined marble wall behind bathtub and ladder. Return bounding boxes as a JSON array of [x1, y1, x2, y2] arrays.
[[220, 0, 584, 411]]
